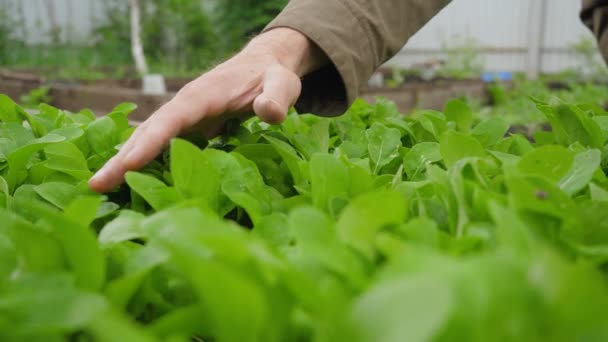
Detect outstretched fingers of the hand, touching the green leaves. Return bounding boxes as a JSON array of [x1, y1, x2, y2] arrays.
[[89, 103, 187, 192]]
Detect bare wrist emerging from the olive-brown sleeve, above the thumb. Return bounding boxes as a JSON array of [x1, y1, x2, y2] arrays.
[[243, 27, 328, 77]]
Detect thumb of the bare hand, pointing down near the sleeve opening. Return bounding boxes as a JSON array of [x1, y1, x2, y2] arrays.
[[253, 65, 302, 123]]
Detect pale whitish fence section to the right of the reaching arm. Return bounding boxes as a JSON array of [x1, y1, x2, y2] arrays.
[[389, 0, 599, 73]]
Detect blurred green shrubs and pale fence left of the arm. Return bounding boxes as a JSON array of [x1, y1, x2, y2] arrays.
[[0, 0, 286, 79]]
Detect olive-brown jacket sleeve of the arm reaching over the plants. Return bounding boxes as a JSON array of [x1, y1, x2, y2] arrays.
[[265, 0, 449, 116]]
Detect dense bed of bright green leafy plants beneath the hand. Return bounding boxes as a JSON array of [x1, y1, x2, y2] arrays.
[[0, 91, 608, 342]]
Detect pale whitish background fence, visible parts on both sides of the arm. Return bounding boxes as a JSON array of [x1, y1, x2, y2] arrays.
[[0, 0, 604, 73]]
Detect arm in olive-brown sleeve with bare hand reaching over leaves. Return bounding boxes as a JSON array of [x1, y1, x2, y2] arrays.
[[89, 0, 447, 192]]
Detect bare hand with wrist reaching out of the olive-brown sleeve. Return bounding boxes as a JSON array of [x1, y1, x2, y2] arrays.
[[89, 28, 326, 192]]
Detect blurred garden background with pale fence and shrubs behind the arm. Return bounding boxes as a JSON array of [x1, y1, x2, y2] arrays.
[[0, 0, 608, 120]]
